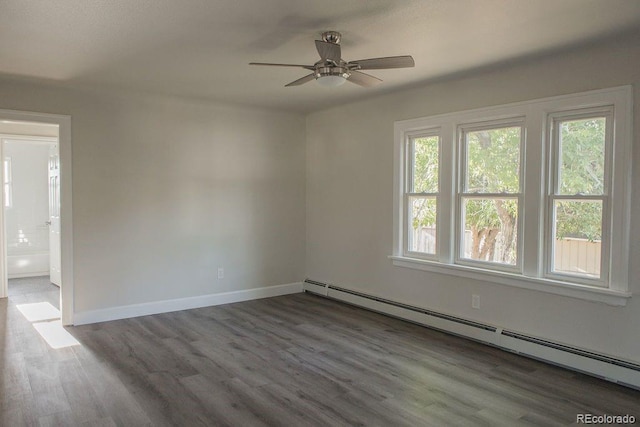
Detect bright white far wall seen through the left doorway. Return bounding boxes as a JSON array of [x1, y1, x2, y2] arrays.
[[3, 141, 49, 278]]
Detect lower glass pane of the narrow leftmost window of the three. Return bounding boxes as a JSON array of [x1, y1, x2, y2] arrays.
[[408, 197, 437, 254]]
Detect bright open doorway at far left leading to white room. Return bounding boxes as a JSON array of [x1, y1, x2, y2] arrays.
[[0, 137, 61, 310]]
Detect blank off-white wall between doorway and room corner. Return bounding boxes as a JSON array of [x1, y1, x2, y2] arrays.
[[0, 79, 305, 313]]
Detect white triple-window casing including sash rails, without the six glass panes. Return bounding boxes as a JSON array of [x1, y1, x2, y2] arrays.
[[390, 86, 633, 305]]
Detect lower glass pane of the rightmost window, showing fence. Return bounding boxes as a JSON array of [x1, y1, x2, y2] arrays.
[[553, 200, 602, 278]]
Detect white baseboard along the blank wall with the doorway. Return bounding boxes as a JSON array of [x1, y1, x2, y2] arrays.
[[73, 282, 302, 325]]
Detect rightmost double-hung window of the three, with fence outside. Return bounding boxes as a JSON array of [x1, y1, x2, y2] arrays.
[[547, 108, 612, 286]]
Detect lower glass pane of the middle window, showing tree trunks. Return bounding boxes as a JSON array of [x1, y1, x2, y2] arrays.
[[461, 198, 518, 265]]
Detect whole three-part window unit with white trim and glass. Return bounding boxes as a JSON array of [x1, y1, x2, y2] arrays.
[[391, 87, 632, 305]]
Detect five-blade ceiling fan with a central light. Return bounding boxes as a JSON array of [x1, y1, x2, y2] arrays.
[[249, 31, 415, 87]]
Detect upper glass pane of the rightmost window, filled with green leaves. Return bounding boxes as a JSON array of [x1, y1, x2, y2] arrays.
[[558, 117, 607, 195]]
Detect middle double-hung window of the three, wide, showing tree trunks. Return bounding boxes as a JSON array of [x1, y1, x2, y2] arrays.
[[457, 123, 524, 268]]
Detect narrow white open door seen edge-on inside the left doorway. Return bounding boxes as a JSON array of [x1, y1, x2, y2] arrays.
[[48, 144, 62, 286]]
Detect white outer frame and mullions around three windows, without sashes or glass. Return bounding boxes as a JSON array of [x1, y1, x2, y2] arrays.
[[390, 86, 633, 306]]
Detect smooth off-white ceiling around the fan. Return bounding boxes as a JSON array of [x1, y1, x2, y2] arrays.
[[0, 0, 640, 112]]
